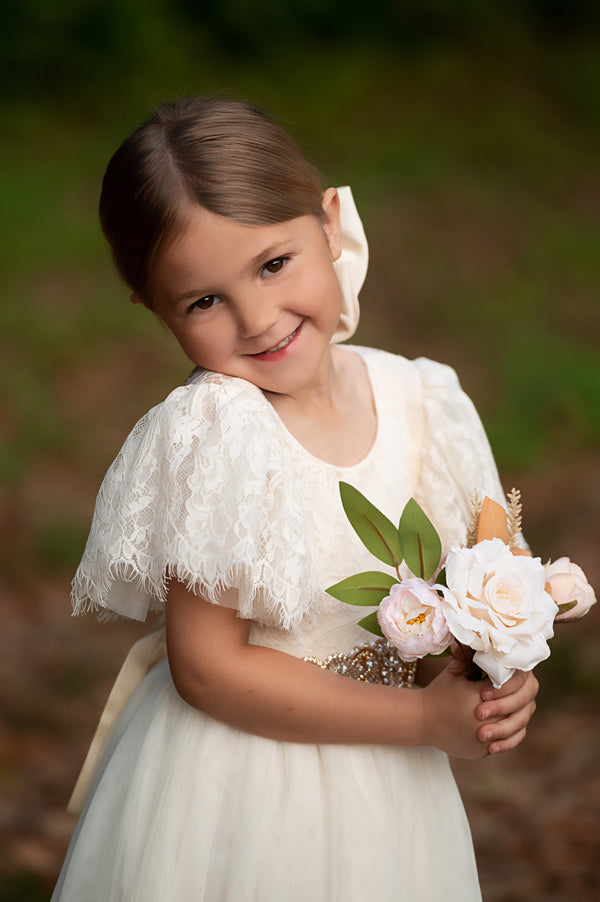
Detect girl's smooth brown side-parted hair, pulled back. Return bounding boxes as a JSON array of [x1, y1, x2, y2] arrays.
[[100, 97, 324, 303]]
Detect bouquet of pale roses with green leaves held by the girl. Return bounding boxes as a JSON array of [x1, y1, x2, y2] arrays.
[[327, 482, 596, 688]]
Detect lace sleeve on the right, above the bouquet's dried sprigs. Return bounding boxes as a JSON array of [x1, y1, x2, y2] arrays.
[[415, 358, 506, 549]]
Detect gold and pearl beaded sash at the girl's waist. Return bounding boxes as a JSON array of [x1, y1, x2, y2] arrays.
[[304, 639, 417, 688]]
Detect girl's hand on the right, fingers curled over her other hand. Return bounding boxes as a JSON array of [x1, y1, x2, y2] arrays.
[[475, 670, 539, 755]]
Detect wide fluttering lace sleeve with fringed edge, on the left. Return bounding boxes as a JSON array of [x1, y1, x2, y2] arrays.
[[72, 374, 320, 629]]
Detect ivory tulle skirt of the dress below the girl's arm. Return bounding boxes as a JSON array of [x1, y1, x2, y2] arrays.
[[52, 659, 481, 902]]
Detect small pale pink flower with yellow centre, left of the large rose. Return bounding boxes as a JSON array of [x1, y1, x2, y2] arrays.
[[377, 577, 450, 661]]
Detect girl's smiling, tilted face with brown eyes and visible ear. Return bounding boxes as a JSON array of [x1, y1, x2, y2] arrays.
[[141, 188, 342, 395]]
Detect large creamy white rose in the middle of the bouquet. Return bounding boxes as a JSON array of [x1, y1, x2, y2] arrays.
[[437, 539, 557, 688]]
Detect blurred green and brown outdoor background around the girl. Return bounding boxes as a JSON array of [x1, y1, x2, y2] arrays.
[[0, 0, 600, 902]]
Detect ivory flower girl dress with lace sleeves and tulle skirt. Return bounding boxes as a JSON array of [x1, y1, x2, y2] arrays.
[[53, 347, 502, 902]]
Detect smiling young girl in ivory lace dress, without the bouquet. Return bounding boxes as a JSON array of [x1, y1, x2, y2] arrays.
[[53, 98, 537, 902]]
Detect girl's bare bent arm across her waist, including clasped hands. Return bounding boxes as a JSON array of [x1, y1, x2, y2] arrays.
[[167, 582, 532, 758]]
